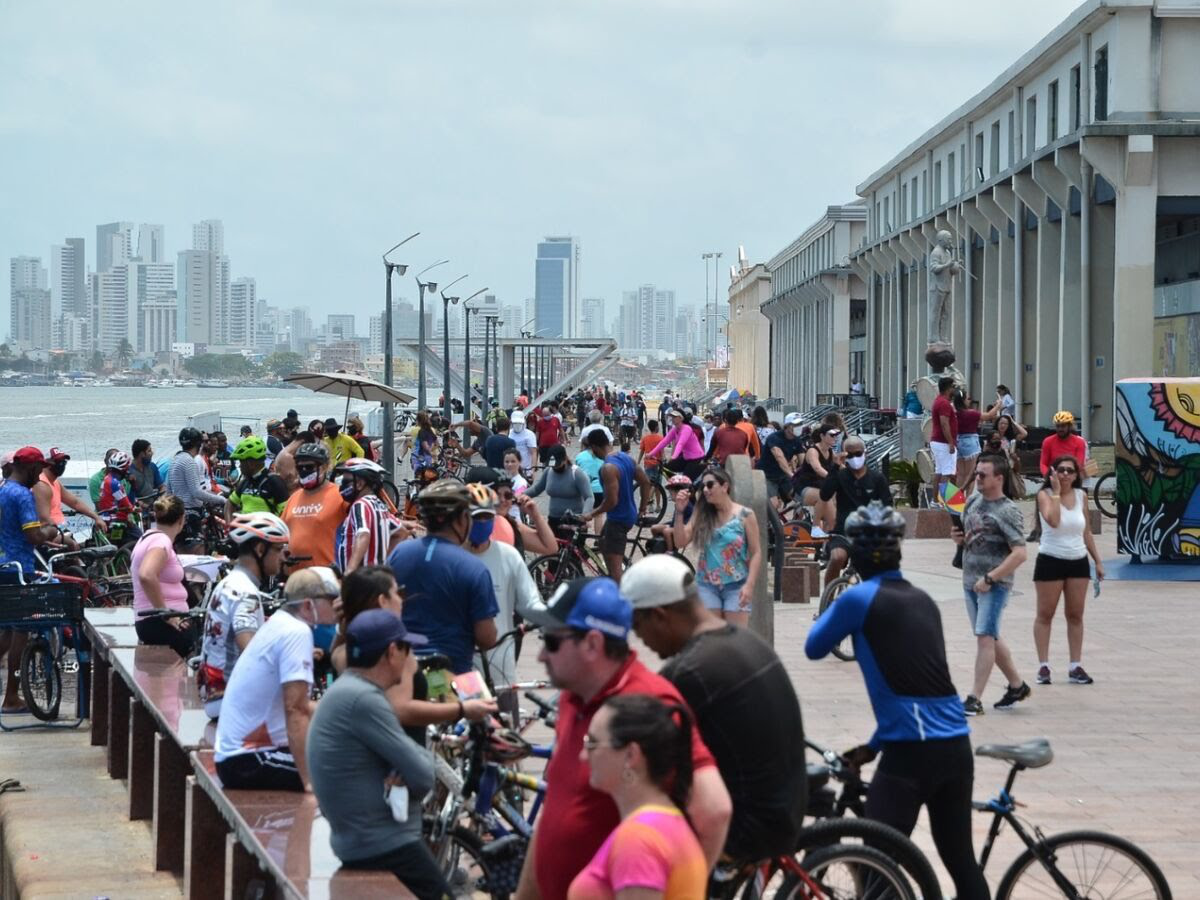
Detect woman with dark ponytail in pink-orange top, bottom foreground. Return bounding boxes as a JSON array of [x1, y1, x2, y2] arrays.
[[566, 694, 708, 900]]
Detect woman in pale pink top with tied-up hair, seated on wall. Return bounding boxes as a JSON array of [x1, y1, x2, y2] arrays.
[[130, 494, 196, 659]]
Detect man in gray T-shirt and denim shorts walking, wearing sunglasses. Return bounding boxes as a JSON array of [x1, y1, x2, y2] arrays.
[[950, 455, 1032, 715]]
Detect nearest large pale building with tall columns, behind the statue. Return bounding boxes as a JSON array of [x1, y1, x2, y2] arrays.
[[851, 0, 1200, 440]]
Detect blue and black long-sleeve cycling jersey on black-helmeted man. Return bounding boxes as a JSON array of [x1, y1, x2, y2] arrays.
[[804, 570, 971, 750]]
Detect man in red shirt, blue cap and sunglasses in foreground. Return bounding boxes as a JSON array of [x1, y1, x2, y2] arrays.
[[516, 577, 731, 900]]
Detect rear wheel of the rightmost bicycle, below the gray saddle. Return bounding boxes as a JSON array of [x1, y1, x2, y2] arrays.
[[996, 832, 1171, 900]]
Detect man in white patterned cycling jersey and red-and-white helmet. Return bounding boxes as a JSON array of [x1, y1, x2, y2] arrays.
[[197, 512, 289, 719]]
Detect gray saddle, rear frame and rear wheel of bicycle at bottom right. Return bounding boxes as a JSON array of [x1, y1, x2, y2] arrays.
[[972, 738, 1171, 900]]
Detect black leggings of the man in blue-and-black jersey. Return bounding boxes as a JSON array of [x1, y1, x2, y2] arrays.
[[866, 736, 991, 900]]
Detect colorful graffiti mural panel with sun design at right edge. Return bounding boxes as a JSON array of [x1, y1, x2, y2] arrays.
[[1116, 378, 1200, 559]]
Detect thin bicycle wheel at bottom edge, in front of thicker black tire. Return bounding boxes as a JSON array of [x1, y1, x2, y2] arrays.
[[775, 844, 917, 900]]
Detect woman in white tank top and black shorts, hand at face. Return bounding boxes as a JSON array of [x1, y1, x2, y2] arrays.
[[1033, 456, 1104, 684]]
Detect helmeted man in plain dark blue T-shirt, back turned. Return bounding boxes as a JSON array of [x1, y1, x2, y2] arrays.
[[388, 479, 499, 674]]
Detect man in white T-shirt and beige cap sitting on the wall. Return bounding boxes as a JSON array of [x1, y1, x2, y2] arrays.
[[215, 566, 340, 791]]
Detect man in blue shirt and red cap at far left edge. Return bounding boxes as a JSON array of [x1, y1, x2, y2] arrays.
[[0, 446, 59, 713]]
